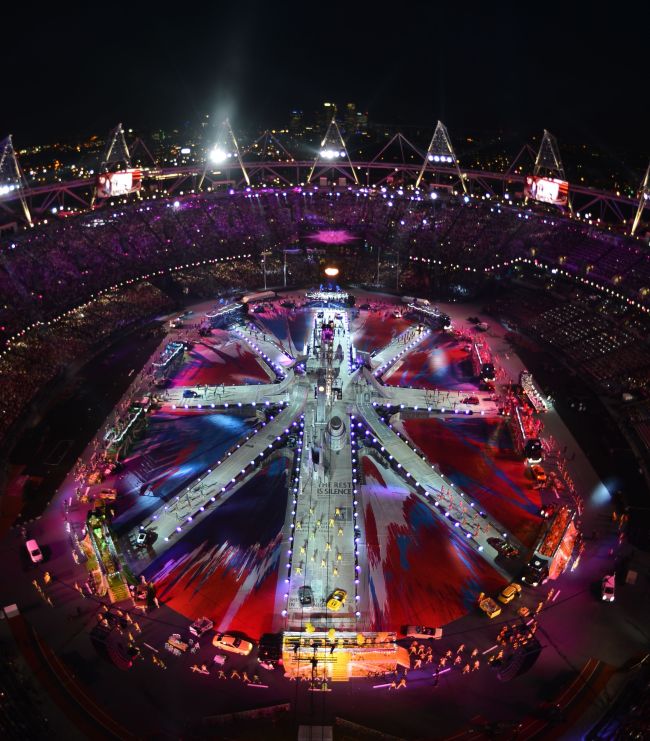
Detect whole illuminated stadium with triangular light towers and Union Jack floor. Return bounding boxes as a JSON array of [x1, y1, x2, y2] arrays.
[[0, 118, 650, 739]]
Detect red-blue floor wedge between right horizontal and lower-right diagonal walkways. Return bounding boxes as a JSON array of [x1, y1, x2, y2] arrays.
[[396, 416, 542, 546]]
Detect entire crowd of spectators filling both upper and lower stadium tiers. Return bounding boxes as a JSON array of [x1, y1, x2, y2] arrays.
[[0, 188, 650, 448]]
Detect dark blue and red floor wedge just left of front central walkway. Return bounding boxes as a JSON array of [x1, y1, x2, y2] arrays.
[[145, 455, 291, 636]]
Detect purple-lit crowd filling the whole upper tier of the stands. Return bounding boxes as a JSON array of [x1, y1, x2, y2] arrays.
[[0, 189, 650, 341]]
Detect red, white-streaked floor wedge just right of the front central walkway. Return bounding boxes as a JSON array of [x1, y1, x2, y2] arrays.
[[361, 455, 504, 630]]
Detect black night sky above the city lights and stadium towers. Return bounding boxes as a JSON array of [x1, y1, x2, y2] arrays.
[[0, 0, 649, 153]]
